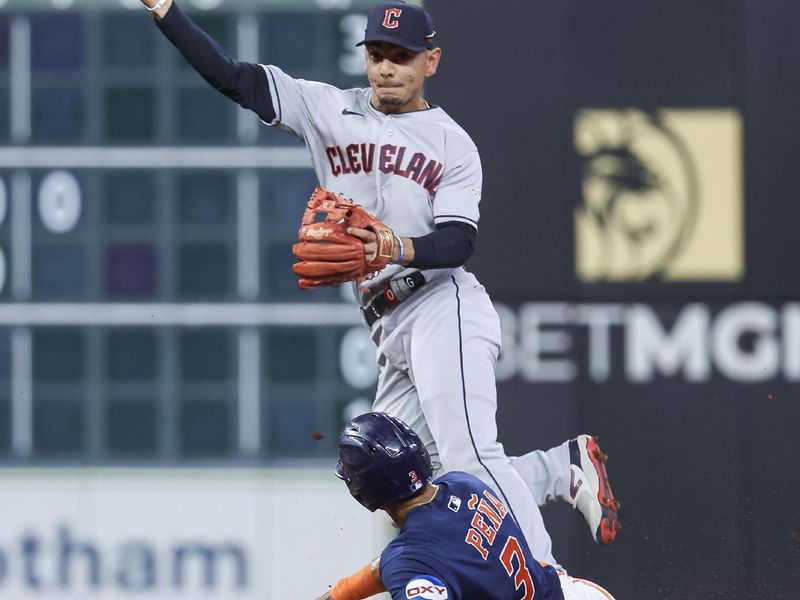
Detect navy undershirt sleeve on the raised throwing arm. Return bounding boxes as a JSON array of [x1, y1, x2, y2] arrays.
[[157, 2, 275, 123]]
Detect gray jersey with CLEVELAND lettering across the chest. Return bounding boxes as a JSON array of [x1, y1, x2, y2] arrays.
[[264, 66, 483, 285]]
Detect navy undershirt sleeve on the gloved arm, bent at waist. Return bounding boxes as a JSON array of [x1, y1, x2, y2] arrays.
[[409, 221, 478, 269]]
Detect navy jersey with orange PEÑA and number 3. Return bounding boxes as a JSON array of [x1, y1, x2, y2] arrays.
[[380, 471, 563, 600]]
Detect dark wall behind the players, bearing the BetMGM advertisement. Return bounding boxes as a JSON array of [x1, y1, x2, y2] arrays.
[[427, 0, 800, 600]]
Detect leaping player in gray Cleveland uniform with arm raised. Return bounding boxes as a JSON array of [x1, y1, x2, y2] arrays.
[[142, 0, 619, 565]]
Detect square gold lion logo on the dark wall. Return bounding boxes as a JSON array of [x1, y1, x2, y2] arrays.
[[575, 110, 743, 281]]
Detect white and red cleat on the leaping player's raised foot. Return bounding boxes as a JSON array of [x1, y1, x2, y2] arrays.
[[567, 434, 622, 544]]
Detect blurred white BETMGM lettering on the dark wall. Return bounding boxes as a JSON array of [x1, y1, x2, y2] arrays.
[[495, 301, 800, 384]]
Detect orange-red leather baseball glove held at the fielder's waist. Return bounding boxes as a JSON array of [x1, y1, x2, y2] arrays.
[[292, 187, 395, 289]]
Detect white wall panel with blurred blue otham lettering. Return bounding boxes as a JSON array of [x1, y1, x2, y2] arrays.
[[0, 469, 388, 600]]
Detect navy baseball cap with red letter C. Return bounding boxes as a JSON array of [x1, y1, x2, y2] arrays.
[[356, 2, 436, 52]]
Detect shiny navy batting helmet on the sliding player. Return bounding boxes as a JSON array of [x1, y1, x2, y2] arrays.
[[336, 412, 433, 512]]
